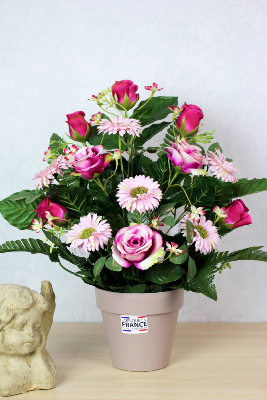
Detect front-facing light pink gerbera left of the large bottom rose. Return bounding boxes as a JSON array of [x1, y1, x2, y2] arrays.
[[66, 214, 112, 254]]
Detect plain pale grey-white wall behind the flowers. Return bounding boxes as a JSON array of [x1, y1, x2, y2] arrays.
[[0, 0, 267, 321]]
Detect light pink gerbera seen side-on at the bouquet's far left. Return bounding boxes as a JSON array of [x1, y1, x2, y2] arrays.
[[32, 156, 68, 189]]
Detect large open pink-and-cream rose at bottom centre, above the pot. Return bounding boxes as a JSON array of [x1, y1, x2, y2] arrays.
[[112, 225, 164, 270]]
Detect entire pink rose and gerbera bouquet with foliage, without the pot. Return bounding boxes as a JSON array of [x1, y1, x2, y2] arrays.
[[0, 80, 267, 300]]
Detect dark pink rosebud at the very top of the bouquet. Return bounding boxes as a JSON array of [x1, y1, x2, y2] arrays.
[[111, 79, 139, 110]]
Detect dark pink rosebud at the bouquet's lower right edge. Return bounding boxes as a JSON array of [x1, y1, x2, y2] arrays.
[[222, 199, 252, 229]]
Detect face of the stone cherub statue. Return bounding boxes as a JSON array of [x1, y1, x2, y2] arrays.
[[0, 306, 42, 356]]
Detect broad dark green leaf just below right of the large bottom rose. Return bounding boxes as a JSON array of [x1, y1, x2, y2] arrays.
[[146, 262, 186, 283]]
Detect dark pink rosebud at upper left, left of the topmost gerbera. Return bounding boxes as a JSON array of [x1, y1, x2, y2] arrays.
[[66, 111, 91, 142]]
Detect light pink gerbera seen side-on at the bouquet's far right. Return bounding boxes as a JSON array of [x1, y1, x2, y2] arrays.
[[207, 149, 241, 182]]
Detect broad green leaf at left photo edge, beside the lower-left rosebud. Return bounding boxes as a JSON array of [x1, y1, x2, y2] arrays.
[[0, 193, 40, 230]]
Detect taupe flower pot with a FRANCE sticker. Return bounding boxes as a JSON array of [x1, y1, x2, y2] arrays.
[[96, 288, 184, 371]]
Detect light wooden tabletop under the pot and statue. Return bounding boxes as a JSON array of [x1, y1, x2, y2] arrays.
[[13, 323, 267, 400]]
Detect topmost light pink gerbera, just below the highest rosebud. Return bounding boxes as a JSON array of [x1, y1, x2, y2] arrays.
[[97, 117, 142, 137]]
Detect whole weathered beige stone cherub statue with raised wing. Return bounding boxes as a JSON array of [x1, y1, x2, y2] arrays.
[[0, 281, 56, 396]]
